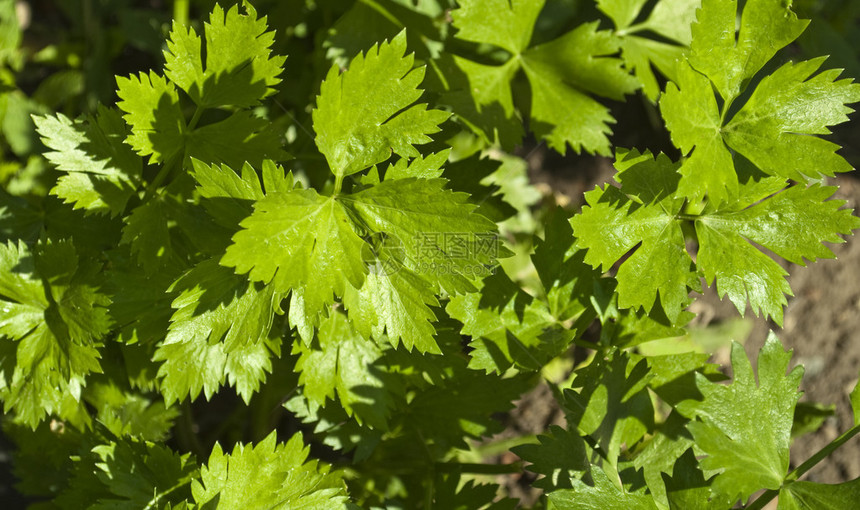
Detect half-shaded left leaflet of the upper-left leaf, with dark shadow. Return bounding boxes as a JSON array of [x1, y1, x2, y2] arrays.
[[116, 71, 187, 164]]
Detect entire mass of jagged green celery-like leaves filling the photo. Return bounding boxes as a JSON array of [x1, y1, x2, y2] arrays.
[[0, 0, 860, 509]]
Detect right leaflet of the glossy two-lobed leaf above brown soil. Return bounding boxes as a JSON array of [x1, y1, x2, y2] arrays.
[[696, 184, 860, 324]]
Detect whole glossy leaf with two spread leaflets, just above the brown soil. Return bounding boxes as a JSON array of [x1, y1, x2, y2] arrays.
[[571, 151, 860, 325]]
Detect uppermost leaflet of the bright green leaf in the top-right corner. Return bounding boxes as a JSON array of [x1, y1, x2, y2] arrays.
[[690, 0, 809, 101]]
